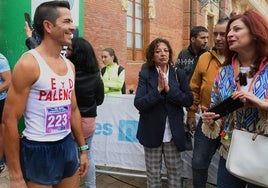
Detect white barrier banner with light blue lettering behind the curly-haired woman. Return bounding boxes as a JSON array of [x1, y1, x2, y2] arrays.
[[92, 95, 219, 184]]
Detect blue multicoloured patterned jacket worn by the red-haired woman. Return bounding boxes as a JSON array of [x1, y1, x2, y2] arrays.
[[211, 57, 268, 139]]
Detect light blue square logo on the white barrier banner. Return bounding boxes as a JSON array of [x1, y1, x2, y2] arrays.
[[118, 120, 138, 142]]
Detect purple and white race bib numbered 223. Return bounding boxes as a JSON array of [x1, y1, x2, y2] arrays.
[[45, 105, 71, 134]]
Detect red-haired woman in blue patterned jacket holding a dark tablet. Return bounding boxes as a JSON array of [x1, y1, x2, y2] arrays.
[[202, 10, 268, 188]]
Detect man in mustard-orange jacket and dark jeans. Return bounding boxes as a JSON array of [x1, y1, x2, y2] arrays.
[[186, 18, 229, 188]]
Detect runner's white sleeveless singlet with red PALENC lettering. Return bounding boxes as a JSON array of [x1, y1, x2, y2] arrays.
[[23, 49, 74, 142]]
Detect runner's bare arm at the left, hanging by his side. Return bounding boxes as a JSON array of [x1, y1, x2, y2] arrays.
[[3, 54, 39, 185]]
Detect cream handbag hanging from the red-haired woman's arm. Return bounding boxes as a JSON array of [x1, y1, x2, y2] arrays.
[[226, 129, 268, 187]]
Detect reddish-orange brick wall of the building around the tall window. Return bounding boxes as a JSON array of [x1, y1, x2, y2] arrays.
[[84, 0, 204, 91]]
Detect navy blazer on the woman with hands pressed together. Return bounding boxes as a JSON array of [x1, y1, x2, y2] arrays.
[[134, 66, 193, 151]]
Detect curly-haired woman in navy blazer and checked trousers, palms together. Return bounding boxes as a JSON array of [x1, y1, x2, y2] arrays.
[[134, 38, 193, 188]]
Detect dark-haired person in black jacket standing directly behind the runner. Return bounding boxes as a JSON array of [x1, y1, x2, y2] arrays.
[[66, 37, 104, 188]]
